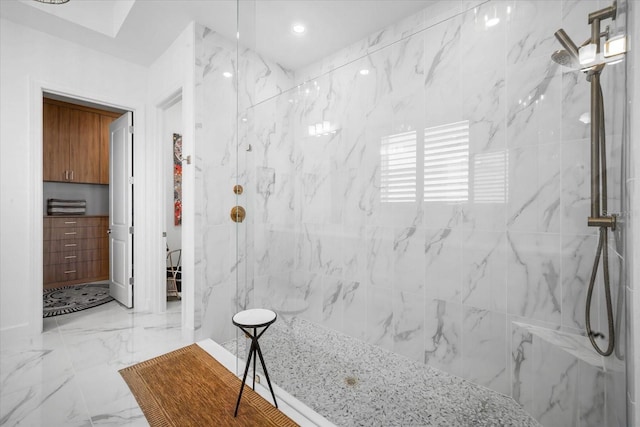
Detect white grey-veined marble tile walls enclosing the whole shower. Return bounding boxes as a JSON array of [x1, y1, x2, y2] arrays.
[[196, 1, 624, 425]]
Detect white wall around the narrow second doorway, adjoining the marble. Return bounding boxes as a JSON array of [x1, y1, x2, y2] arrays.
[[144, 23, 195, 324]]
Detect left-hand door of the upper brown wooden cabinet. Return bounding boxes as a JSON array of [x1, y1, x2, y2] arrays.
[[42, 103, 69, 181]]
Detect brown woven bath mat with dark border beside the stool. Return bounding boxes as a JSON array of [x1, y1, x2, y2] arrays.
[[119, 344, 298, 427]]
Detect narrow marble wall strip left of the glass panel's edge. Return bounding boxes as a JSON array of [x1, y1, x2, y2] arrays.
[[194, 25, 237, 342]]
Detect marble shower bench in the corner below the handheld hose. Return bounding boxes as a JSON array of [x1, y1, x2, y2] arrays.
[[511, 322, 626, 427]]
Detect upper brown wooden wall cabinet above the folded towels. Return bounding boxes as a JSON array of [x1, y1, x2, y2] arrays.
[[42, 98, 119, 184]]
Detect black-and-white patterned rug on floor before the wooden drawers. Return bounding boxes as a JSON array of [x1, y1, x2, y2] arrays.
[[42, 283, 113, 317]]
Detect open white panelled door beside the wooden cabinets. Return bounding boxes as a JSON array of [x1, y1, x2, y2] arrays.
[[109, 112, 133, 308]]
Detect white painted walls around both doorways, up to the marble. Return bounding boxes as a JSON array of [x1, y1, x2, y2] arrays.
[[0, 15, 194, 331]]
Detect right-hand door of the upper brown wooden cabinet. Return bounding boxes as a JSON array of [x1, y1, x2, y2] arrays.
[[69, 109, 100, 184]]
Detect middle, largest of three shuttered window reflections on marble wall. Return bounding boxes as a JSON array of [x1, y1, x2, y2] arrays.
[[423, 120, 469, 202]]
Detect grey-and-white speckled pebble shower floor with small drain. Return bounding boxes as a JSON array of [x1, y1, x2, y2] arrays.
[[225, 315, 539, 426]]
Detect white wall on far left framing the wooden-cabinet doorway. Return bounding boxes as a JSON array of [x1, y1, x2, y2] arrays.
[[0, 19, 147, 331]]
